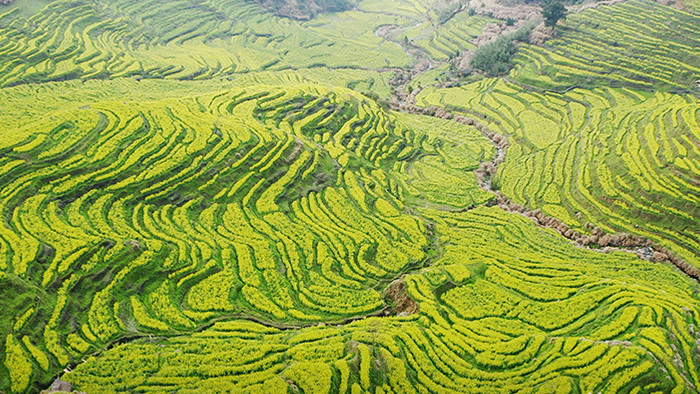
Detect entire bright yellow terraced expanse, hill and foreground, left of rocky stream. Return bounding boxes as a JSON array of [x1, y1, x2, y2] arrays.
[[2, 78, 700, 392]]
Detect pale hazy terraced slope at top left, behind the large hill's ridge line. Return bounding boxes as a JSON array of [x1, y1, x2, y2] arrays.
[[0, 0, 410, 86]]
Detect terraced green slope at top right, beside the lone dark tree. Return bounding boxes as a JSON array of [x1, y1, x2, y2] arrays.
[[513, 0, 700, 92]]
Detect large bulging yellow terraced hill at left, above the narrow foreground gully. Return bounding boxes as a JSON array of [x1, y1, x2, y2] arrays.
[[0, 85, 493, 391]]
